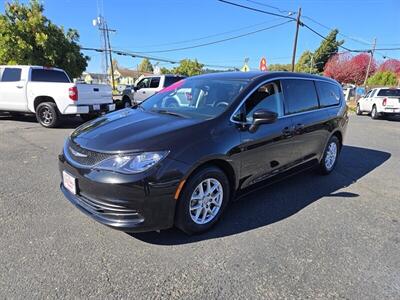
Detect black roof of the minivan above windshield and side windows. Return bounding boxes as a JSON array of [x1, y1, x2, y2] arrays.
[[190, 71, 338, 84]]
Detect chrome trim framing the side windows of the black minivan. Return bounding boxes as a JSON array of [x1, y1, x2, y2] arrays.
[[229, 77, 343, 125]]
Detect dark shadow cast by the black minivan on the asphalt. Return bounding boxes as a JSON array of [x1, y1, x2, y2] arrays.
[[130, 146, 391, 245]]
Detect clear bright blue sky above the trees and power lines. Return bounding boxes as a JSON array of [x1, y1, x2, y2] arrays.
[[0, 0, 400, 72]]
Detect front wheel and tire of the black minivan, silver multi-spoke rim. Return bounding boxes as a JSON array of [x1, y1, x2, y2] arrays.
[[175, 166, 230, 234]]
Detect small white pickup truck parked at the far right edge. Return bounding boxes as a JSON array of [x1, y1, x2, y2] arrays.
[[356, 87, 400, 119]]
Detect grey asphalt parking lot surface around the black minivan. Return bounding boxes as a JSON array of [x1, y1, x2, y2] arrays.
[[0, 115, 400, 299]]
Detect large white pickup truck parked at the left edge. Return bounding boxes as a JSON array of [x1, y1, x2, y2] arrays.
[[0, 66, 115, 127]]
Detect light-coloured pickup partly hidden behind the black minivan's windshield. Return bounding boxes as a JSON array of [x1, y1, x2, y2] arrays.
[[131, 75, 185, 103]]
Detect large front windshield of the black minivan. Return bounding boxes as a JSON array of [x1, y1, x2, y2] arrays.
[[140, 78, 248, 119]]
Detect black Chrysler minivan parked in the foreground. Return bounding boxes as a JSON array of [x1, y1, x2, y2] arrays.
[[59, 72, 348, 234]]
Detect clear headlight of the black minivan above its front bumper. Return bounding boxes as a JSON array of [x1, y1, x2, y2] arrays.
[[93, 151, 168, 174]]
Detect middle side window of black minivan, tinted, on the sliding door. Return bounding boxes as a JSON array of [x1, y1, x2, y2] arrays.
[[282, 79, 318, 114]]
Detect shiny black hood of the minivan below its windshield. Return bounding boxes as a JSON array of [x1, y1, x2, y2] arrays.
[[71, 108, 203, 152]]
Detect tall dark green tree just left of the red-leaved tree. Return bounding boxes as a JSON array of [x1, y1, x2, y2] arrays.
[[313, 29, 344, 73]]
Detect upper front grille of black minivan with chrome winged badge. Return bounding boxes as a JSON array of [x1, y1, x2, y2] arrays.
[[64, 139, 113, 167]]
